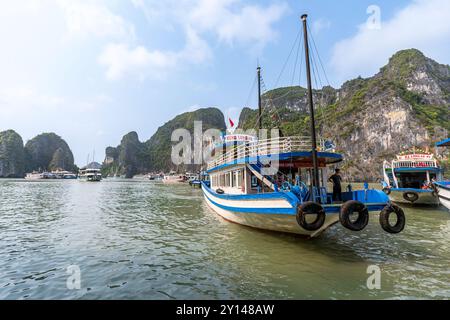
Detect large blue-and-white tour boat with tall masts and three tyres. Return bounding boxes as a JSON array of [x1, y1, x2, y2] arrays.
[[202, 15, 405, 237]]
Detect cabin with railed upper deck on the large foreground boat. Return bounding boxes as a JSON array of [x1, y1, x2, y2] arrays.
[[208, 137, 342, 203]]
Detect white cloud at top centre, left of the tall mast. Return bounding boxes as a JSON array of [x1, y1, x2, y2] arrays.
[[112, 0, 287, 80]]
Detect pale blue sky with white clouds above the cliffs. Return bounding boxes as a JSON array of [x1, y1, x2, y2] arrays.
[[0, 0, 450, 164]]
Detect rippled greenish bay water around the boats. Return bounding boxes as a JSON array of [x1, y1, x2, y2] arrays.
[[0, 180, 450, 299]]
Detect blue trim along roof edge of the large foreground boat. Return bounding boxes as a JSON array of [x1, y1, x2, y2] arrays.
[[207, 151, 343, 173]]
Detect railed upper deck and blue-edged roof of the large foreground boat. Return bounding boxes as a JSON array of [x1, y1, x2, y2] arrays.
[[208, 137, 343, 173]]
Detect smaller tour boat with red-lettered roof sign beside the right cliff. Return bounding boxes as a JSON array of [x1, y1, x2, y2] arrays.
[[382, 150, 442, 205]]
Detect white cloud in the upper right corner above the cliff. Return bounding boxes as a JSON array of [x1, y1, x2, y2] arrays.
[[331, 0, 450, 82]]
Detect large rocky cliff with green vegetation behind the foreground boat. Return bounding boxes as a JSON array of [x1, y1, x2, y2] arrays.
[[239, 49, 450, 180]]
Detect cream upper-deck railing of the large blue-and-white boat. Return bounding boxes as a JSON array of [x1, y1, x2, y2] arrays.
[[208, 136, 325, 170]]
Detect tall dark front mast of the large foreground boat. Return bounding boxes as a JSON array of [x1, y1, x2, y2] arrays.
[[301, 14, 320, 188]]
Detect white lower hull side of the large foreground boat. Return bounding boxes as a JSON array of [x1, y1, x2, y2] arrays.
[[203, 191, 339, 238]]
